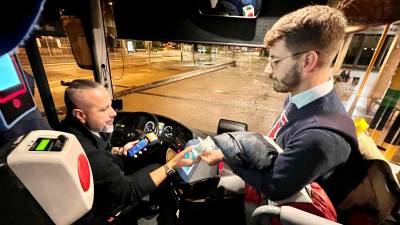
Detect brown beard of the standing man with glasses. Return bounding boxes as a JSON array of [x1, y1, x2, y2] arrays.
[[272, 63, 300, 93]]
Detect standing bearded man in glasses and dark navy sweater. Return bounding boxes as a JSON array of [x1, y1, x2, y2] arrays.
[[201, 5, 367, 214]]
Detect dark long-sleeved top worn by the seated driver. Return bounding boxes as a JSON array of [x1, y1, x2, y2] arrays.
[[60, 117, 156, 224]]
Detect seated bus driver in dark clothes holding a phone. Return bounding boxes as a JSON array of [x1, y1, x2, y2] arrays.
[[60, 80, 194, 224]]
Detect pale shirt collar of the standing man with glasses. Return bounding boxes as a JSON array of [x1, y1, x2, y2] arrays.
[[289, 79, 333, 109]]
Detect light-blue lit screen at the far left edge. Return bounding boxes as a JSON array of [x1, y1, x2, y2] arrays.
[[0, 54, 21, 91]]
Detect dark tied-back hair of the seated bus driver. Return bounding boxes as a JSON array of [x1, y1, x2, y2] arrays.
[[62, 79, 102, 117]]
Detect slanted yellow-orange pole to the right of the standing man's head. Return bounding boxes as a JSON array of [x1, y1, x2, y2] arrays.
[[348, 24, 390, 116]]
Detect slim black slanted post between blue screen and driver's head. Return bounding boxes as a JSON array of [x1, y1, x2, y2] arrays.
[[25, 36, 60, 129]]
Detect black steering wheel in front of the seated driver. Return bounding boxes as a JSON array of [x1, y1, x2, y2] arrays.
[[111, 112, 158, 146]]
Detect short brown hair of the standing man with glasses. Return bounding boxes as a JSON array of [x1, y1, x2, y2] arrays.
[[264, 5, 347, 64]]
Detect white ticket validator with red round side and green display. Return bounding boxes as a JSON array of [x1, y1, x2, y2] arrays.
[[0, 130, 94, 225]]
